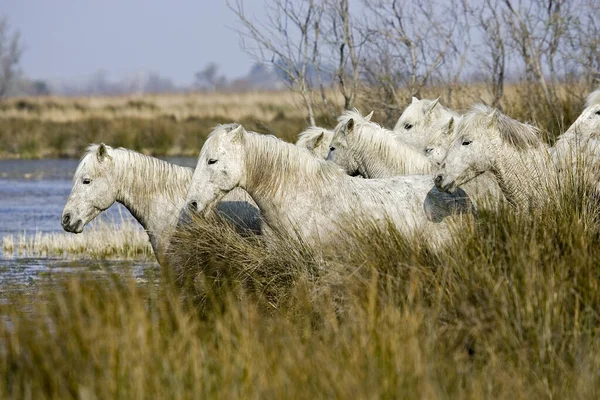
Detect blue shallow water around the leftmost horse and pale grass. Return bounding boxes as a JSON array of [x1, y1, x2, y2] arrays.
[[0, 158, 196, 290]]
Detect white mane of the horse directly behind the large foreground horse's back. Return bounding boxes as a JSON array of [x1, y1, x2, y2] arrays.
[[335, 109, 432, 174]]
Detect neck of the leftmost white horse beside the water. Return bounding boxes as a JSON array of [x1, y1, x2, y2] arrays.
[[114, 151, 192, 234]]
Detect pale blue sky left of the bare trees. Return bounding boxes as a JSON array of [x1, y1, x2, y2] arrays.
[[0, 0, 263, 84]]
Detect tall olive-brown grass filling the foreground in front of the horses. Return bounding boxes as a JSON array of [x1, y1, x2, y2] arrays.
[[0, 173, 600, 399]]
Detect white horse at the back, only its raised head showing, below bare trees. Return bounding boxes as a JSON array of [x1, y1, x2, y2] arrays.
[[394, 97, 460, 149]]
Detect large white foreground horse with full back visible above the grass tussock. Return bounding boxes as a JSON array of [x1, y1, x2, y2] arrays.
[[187, 124, 471, 252]]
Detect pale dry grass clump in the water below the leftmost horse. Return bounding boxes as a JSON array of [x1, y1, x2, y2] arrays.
[[2, 219, 153, 259]]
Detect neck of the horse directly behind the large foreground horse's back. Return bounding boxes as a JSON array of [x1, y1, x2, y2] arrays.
[[353, 123, 431, 178]]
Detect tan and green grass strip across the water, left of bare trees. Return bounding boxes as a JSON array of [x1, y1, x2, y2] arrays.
[[0, 92, 333, 158]]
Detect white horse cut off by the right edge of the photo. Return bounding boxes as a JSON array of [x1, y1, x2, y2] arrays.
[[551, 89, 600, 170]]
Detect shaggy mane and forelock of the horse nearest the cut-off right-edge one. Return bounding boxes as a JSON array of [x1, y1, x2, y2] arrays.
[[456, 104, 543, 150]]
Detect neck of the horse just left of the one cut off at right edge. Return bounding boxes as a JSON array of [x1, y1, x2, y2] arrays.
[[492, 145, 552, 210]]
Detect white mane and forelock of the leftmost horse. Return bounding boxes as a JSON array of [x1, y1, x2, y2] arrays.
[[74, 144, 194, 202]]
